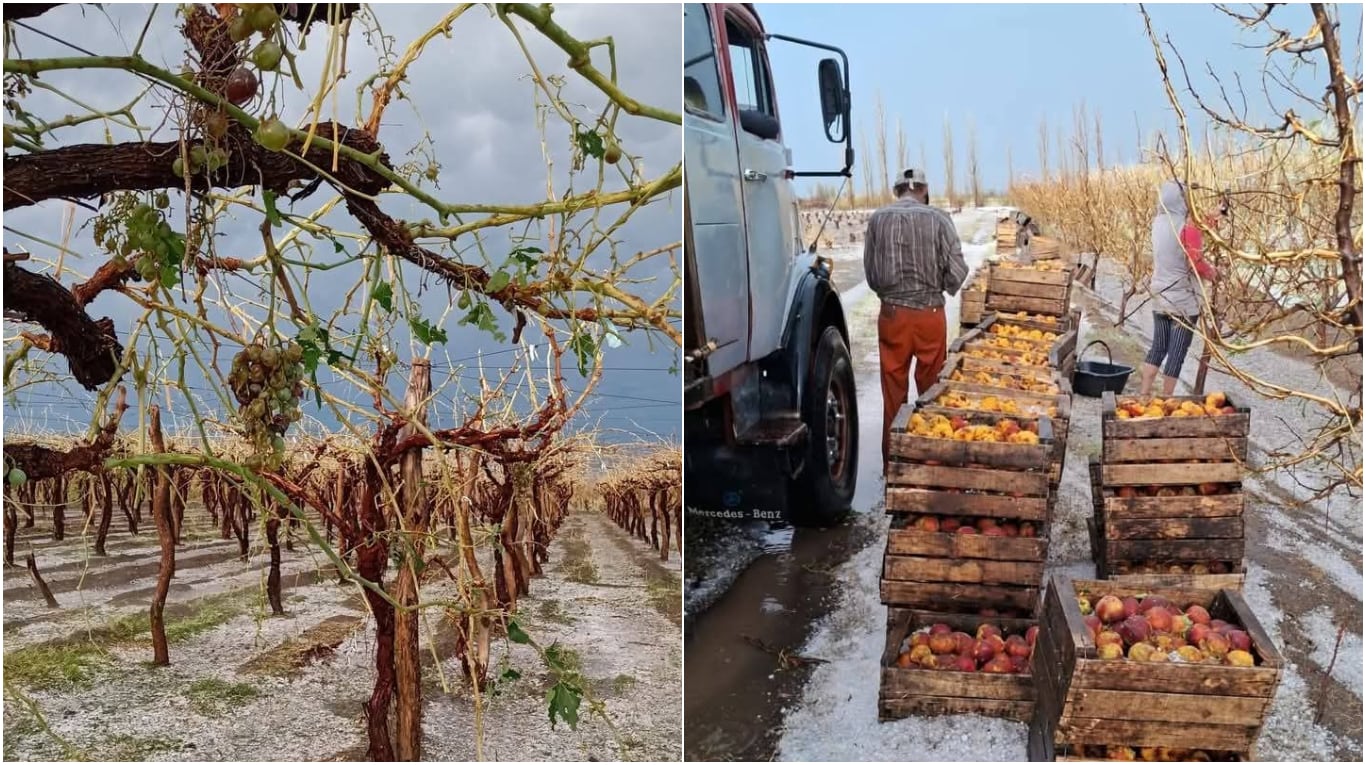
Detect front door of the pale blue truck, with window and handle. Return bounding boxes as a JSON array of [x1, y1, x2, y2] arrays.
[[725, 8, 800, 361]]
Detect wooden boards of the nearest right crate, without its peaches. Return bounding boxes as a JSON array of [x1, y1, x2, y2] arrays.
[[1031, 575, 1283, 751]]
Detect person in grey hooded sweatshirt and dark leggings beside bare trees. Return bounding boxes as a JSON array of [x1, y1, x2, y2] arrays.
[[1139, 180, 1218, 398]]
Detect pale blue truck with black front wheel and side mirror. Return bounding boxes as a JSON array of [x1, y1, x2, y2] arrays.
[[683, 3, 858, 523]]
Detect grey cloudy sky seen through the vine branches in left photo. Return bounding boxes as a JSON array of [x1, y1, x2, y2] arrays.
[[4, 4, 682, 440]]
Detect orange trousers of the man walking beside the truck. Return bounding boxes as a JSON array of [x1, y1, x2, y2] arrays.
[[877, 303, 948, 475]]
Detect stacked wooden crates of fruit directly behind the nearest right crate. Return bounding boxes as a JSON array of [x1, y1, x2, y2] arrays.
[[1089, 392, 1251, 581]]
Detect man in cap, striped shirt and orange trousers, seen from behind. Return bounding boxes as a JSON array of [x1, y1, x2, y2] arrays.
[[863, 169, 967, 474]]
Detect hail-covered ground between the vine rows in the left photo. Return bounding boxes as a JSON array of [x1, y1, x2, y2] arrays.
[[4, 511, 682, 761]]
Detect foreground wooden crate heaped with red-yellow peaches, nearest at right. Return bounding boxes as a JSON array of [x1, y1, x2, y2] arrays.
[[1029, 576, 1283, 762]]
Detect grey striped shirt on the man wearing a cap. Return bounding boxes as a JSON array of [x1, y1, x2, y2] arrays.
[[863, 197, 967, 309]]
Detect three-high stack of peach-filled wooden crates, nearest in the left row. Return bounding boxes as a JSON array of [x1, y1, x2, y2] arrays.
[[878, 404, 1053, 720]]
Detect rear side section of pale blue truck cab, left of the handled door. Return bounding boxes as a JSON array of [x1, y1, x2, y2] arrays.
[[683, 3, 750, 377]]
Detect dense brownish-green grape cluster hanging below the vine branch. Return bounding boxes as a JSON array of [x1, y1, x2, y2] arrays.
[[228, 343, 303, 470]]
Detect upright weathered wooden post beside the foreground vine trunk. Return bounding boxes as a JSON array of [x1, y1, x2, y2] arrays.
[[393, 358, 432, 762]]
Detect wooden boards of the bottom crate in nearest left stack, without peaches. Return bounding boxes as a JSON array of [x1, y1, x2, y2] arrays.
[[877, 607, 1034, 721]]
